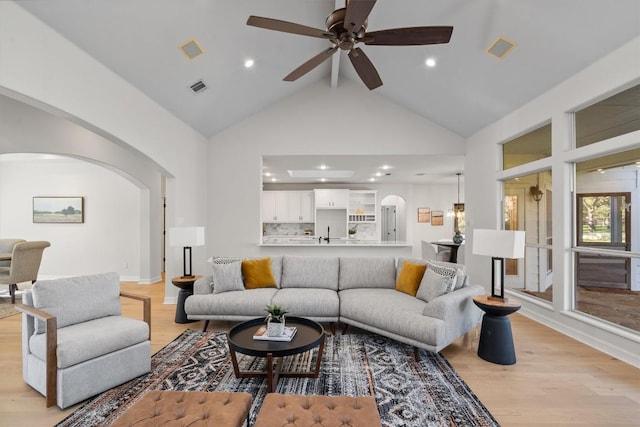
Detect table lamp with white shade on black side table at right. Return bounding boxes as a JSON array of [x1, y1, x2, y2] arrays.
[[473, 229, 524, 301]]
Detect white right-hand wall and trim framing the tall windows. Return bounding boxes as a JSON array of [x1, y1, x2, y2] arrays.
[[465, 38, 640, 366]]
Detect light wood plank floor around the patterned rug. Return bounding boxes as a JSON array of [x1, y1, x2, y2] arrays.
[[0, 283, 640, 427]]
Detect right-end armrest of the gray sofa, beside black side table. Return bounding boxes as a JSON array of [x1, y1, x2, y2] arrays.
[[422, 285, 484, 324]]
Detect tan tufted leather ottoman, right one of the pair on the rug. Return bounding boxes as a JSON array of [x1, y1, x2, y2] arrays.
[[253, 393, 381, 427]]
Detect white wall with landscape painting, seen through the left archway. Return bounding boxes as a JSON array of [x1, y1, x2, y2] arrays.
[[0, 155, 140, 281]]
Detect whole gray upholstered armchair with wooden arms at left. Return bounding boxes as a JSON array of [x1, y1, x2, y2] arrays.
[[16, 273, 151, 409]]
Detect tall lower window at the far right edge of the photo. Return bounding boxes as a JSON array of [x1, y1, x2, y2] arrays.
[[573, 149, 640, 331]]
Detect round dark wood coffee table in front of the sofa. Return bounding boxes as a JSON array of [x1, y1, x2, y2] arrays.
[[227, 317, 324, 392]]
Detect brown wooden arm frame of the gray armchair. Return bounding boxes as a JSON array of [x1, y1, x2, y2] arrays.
[[15, 291, 151, 408]]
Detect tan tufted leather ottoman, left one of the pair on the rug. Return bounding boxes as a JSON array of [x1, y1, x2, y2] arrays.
[[111, 390, 251, 427]]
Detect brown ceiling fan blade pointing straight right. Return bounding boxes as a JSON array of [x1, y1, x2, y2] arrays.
[[360, 27, 453, 46]]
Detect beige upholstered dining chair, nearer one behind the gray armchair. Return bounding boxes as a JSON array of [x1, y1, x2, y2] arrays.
[[0, 241, 51, 304]]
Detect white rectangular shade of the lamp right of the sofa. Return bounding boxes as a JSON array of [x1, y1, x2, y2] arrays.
[[473, 229, 524, 259]]
